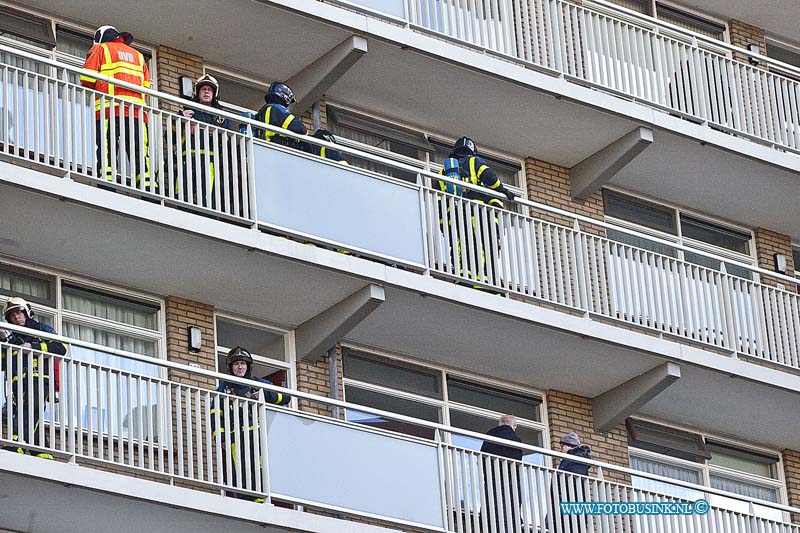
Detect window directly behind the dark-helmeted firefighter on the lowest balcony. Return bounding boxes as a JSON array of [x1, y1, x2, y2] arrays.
[[215, 314, 292, 387]]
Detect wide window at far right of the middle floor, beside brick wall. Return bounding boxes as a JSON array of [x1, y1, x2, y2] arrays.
[[603, 189, 754, 279]]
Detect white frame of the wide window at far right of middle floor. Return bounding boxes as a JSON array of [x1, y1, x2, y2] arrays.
[[605, 187, 760, 274]]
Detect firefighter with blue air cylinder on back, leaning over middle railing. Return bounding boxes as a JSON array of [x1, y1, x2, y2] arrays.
[[438, 137, 514, 289]]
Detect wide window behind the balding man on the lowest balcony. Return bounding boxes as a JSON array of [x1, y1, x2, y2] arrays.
[[344, 348, 546, 464]]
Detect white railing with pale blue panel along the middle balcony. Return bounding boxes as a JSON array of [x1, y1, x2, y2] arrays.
[[0, 47, 800, 369]]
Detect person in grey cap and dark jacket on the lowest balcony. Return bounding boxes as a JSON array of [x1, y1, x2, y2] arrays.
[[546, 431, 592, 533]]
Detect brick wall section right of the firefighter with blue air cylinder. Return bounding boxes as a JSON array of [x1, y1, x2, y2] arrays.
[[525, 157, 604, 235]]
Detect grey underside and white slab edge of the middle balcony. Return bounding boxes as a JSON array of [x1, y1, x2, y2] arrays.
[[0, 176, 800, 449]]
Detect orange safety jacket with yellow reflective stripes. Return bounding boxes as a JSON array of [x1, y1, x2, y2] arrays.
[[81, 40, 150, 121]]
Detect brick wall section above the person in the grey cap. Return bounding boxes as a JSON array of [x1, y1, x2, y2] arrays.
[[547, 390, 630, 484]]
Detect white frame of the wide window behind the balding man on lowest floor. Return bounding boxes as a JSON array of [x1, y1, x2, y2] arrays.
[[342, 343, 552, 460]]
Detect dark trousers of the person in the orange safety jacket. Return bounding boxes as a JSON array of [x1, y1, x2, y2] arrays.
[[95, 116, 153, 191]]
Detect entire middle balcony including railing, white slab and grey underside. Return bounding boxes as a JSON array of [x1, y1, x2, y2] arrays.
[[0, 46, 800, 454]]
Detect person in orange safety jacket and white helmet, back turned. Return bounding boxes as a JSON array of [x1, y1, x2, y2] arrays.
[[81, 26, 158, 192]]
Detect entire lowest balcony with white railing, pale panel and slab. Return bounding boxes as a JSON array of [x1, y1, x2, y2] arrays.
[[0, 326, 798, 533]]
